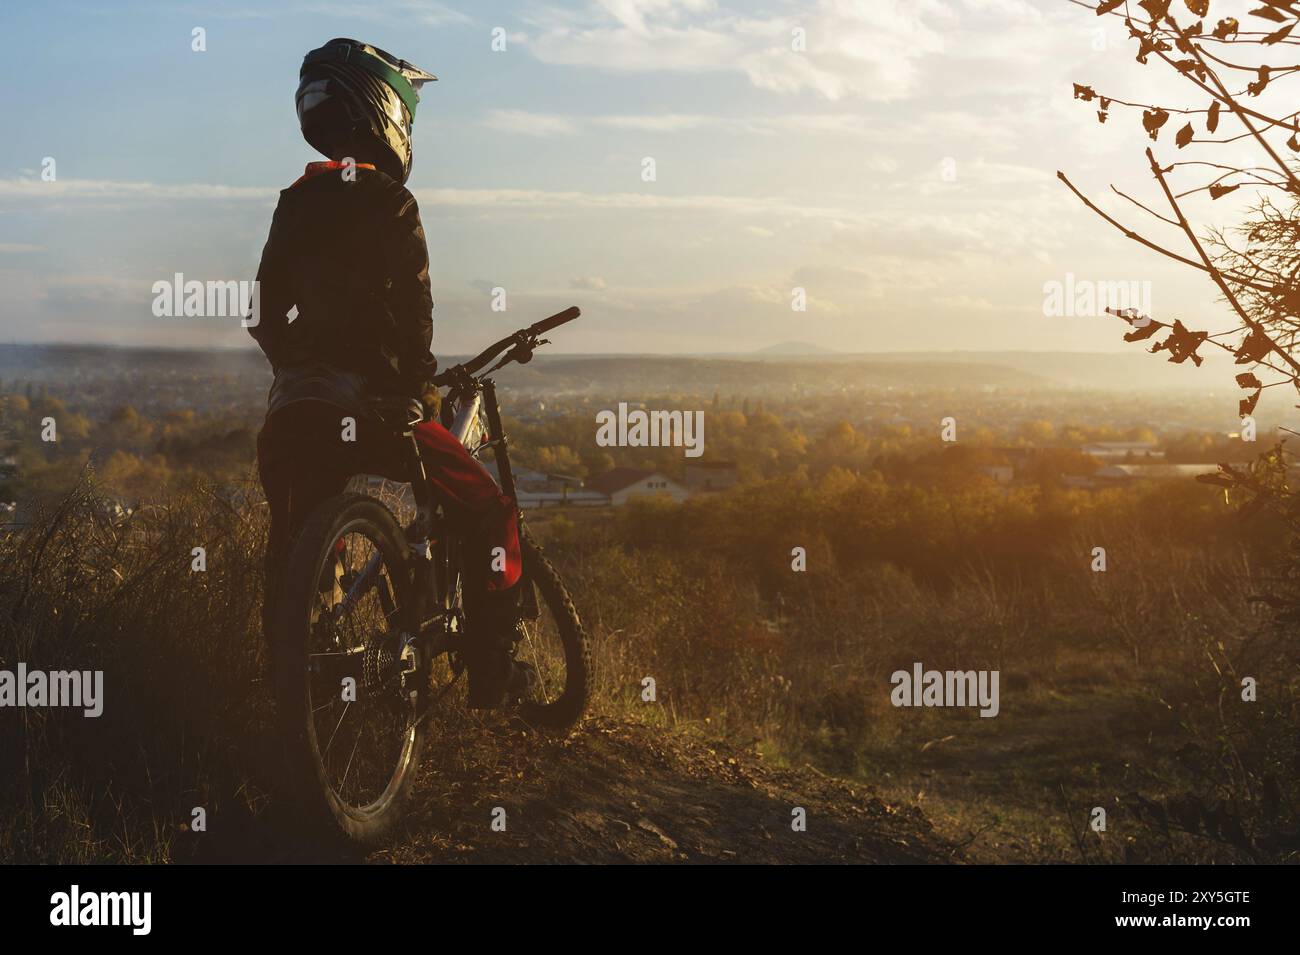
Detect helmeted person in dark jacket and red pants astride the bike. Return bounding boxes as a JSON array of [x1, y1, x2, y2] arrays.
[[250, 39, 534, 708]]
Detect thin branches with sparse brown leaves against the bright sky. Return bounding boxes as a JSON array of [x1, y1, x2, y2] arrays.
[[1057, 0, 1300, 414]]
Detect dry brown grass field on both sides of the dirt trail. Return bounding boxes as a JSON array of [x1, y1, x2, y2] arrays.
[[0, 485, 1300, 861]]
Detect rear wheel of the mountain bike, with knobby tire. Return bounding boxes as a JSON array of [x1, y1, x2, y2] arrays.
[[272, 494, 428, 845]]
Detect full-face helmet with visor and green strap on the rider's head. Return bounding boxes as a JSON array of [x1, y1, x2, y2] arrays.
[[295, 38, 437, 183]]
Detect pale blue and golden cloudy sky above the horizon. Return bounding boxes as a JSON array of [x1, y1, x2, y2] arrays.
[[0, 0, 1284, 360]]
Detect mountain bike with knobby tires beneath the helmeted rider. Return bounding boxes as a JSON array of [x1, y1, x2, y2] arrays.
[[273, 308, 590, 845]]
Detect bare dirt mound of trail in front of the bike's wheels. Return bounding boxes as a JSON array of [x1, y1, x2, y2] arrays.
[[371, 719, 957, 863]]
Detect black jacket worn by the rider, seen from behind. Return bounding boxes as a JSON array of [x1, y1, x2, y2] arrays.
[[248, 164, 437, 411]]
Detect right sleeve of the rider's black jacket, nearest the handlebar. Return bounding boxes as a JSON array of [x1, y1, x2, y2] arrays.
[[385, 183, 438, 395]]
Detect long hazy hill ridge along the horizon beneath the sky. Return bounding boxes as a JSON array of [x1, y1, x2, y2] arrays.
[[0, 342, 1243, 407]]
